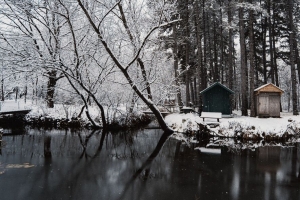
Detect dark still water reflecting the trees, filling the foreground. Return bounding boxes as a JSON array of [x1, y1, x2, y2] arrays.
[[0, 129, 300, 200]]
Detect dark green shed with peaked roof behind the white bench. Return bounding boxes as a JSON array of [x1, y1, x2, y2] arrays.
[[200, 82, 234, 115]]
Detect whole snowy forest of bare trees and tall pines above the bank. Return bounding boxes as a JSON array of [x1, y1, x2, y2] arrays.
[[0, 0, 300, 130]]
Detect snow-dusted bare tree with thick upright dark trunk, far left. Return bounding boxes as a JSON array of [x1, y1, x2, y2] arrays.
[[1, 0, 64, 108]]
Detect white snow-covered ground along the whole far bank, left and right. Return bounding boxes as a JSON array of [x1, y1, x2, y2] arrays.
[[0, 99, 300, 137]]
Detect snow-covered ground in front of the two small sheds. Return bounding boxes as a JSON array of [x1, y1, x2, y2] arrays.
[[165, 112, 300, 137]]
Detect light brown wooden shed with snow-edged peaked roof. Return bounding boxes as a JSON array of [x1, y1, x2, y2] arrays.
[[254, 83, 284, 117]]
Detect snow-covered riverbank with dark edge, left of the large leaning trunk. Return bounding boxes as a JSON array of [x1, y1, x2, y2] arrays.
[[0, 99, 152, 130]]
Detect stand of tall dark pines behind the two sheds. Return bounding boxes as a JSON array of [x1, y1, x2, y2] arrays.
[[163, 0, 300, 116]]
